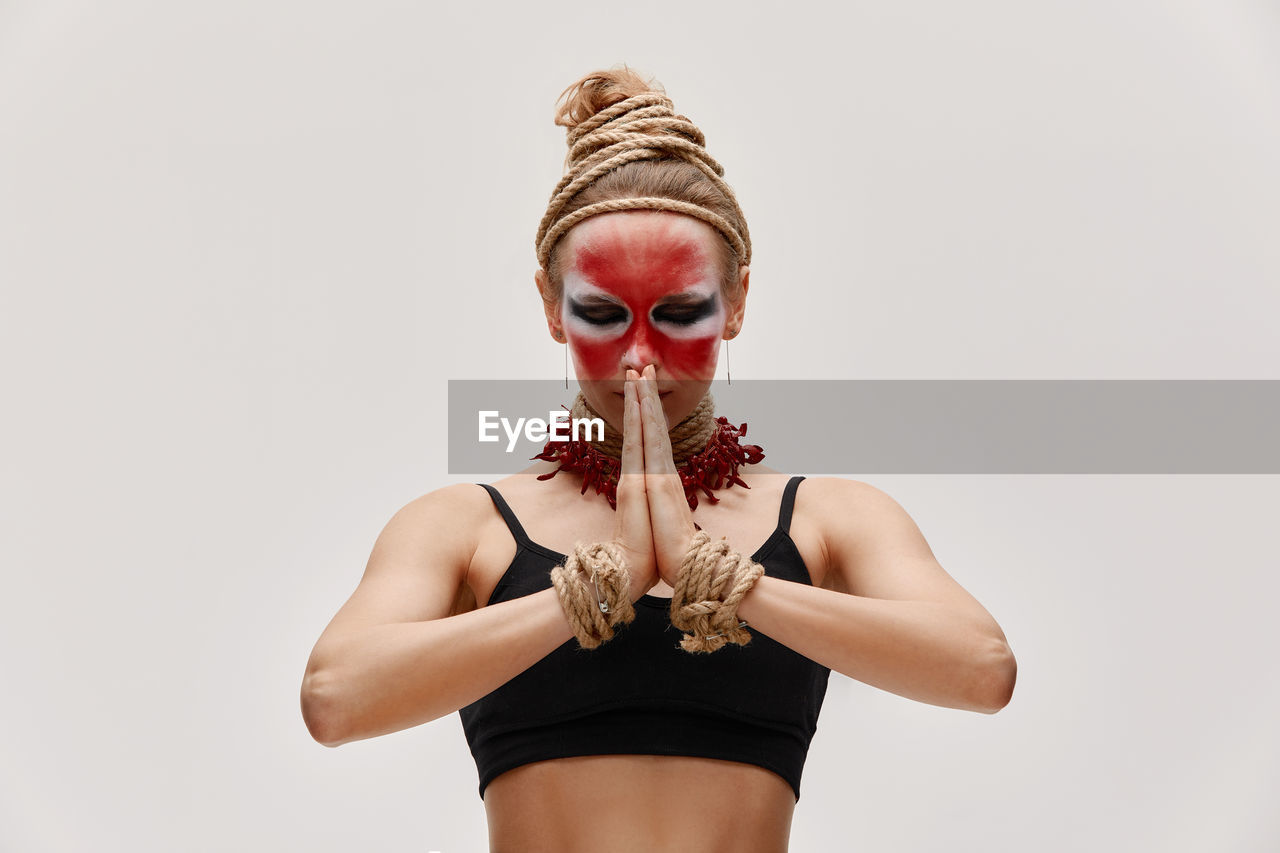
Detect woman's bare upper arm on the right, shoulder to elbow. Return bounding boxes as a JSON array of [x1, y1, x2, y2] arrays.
[[801, 478, 1000, 631]]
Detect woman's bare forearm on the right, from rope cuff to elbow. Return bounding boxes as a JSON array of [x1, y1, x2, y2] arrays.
[[737, 576, 1016, 713]]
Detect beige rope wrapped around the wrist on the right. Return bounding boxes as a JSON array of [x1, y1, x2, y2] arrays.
[[671, 530, 764, 652]]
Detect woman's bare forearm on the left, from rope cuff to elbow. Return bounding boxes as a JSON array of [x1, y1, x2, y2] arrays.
[[302, 589, 573, 747]]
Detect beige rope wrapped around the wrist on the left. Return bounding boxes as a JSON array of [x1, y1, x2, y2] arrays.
[[552, 542, 636, 648]]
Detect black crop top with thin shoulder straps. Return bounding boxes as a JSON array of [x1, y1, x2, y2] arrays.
[[458, 476, 831, 800]]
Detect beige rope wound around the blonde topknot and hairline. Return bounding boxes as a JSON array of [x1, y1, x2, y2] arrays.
[[534, 92, 751, 269]]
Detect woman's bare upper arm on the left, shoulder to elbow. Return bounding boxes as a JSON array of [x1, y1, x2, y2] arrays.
[[312, 483, 489, 658]]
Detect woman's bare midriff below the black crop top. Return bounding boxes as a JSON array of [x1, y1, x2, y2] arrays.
[[484, 756, 796, 853]]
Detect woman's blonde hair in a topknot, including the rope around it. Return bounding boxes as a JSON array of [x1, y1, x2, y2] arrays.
[[536, 65, 751, 302]]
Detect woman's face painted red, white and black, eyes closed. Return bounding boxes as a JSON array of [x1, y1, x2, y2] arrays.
[[549, 210, 741, 429]]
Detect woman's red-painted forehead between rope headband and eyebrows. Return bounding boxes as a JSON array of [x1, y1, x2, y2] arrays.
[[564, 210, 719, 297]]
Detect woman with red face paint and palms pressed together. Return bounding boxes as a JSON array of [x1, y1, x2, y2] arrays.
[[302, 69, 1016, 853]]
